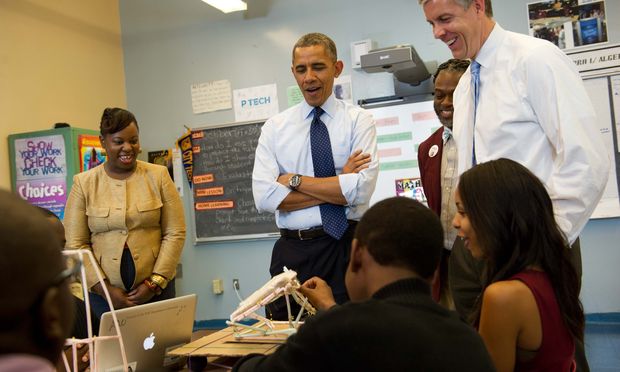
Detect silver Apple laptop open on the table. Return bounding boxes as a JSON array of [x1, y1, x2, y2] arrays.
[[95, 294, 196, 372]]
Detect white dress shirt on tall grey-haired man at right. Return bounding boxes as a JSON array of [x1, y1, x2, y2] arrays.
[[453, 24, 609, 243]]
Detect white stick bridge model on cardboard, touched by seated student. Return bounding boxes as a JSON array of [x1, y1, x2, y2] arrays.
[[226, 267, 316, 339]]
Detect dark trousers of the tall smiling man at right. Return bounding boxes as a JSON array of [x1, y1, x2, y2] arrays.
[[448, 238, 590, 372]]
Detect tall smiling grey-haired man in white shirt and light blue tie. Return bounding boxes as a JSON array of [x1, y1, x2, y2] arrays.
[[419, 0, 609, 315]]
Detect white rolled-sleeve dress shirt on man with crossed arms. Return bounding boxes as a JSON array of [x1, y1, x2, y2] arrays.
[[252, 94, 378, 229]]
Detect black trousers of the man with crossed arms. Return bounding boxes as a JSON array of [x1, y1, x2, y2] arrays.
[[265, 225, 355, 320]]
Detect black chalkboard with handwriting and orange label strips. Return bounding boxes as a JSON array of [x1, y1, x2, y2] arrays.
[[192, 121, 279, 241]]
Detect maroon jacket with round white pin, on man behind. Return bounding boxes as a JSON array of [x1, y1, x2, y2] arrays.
[[418, 126, 443, 216]]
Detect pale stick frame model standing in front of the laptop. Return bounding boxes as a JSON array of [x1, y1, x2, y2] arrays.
[[61, 249, 129, 372]]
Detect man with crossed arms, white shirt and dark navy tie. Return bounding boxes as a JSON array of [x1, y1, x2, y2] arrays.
[[252, 33, 378, 319]]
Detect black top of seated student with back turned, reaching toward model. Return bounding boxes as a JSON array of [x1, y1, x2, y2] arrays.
[[233, 279, 495, 372]]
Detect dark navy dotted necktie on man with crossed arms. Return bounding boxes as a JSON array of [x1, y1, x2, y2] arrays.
[[310, 107, 349, 240]]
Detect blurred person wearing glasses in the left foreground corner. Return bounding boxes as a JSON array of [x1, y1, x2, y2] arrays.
[[0, 190, 73, 371]]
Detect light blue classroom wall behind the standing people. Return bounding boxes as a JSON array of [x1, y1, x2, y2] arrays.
[[120, 0, 620, 319]]
